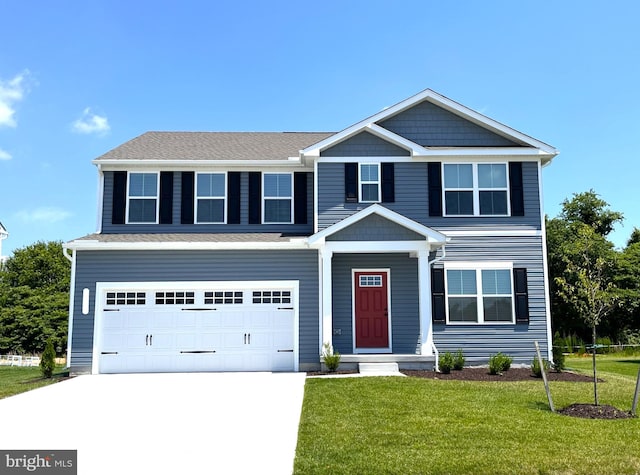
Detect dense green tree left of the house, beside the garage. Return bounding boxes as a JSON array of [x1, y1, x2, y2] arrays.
[[0, 242, 71, 353]]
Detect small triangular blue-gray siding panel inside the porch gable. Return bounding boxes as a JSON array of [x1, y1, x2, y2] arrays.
[[327, 214, 425, 241]]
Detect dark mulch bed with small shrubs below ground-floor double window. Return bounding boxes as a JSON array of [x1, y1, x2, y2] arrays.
[[400, 368, 602, 383]]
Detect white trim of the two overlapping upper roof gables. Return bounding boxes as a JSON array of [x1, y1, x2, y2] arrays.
[[301, 89, 558, 161]]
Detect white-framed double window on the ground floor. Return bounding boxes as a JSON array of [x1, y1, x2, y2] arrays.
[[445, 263, 515, 324]]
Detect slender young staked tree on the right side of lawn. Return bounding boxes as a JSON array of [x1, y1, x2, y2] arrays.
[[556, 223, 617, 406]]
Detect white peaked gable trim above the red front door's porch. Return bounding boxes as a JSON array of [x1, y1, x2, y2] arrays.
[[308, 203, 447, 246]]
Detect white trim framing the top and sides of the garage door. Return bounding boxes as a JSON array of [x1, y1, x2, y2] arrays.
[[92, 280, 300, 374]]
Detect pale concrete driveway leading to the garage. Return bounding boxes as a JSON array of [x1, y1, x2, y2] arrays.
[[0, 373, 305, 475]]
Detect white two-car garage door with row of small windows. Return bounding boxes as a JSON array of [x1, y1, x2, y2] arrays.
[[94, 282, 297, 373]]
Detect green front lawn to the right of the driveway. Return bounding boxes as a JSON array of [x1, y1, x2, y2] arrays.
[[295, 359, 640, 475]]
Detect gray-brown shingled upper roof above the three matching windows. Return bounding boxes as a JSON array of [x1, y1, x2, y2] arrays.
[[96, 132, 333, 161]]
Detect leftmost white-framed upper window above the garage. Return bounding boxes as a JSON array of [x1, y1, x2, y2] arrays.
[[127, 172, 160, 224]]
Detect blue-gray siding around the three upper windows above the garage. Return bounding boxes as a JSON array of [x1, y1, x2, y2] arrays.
[[102, 172, 314, 235]]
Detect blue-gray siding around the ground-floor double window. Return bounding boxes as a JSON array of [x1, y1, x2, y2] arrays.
[[433, 236, 547, 364]]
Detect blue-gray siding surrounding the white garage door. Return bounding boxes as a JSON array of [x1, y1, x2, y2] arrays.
[[71, 250, 320, 371]]
